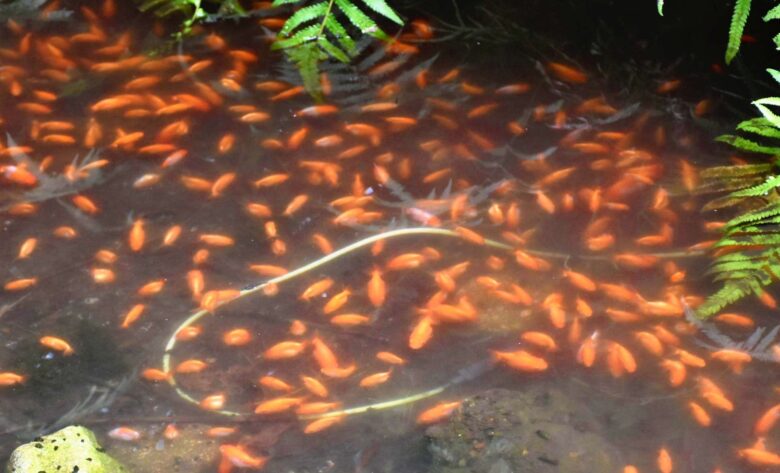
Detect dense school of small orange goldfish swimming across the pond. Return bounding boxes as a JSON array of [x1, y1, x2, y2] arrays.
[[0, 0, 780, 473]]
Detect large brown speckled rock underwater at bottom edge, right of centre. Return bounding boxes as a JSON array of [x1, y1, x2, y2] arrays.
[[426, 388, 622, 473]]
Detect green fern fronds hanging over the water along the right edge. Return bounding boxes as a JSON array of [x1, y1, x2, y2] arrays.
[[698, 0, 780, 317]]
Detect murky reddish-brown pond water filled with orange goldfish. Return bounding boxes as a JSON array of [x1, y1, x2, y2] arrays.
[[0, 2, 778, 472]]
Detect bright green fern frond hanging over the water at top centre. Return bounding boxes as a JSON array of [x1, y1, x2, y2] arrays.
[[273, 0, 403, 99]]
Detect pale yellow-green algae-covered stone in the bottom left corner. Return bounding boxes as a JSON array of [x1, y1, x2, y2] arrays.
[[6, 425, 127, 473]]
